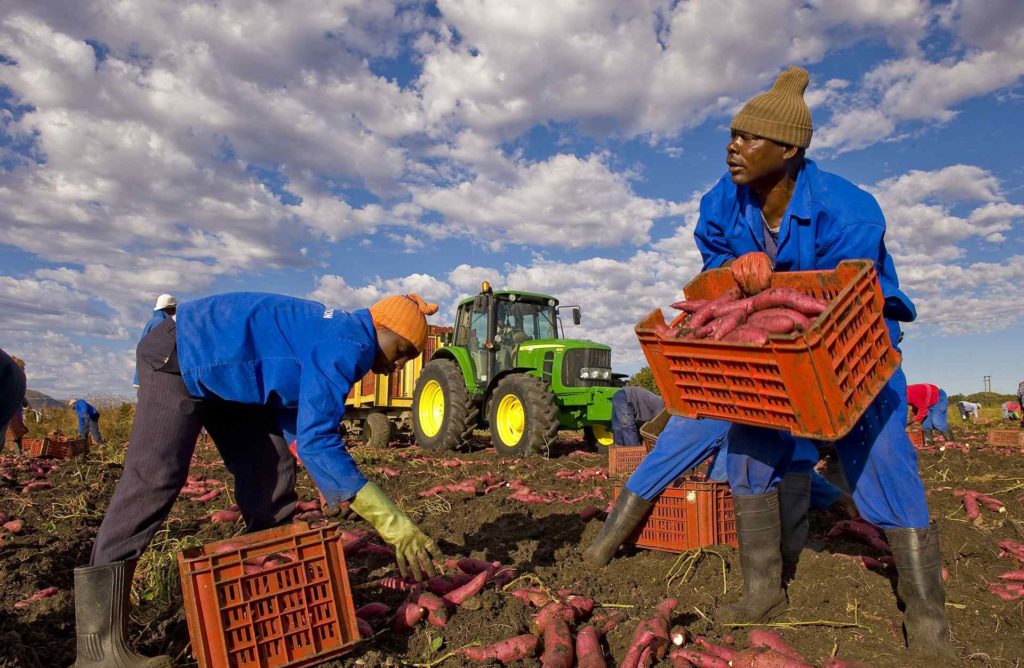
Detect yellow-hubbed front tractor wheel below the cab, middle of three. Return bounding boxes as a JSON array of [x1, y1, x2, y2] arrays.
[[488, 374, 558, 457]]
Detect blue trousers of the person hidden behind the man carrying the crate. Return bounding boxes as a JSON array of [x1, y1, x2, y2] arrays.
[[626, 416, 841, 510]]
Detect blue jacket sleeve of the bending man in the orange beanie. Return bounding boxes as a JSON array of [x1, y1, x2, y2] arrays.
[[296, 339, 367, 505]]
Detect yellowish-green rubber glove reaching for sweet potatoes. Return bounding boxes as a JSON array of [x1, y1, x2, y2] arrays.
[[350, 483, 444, 580]]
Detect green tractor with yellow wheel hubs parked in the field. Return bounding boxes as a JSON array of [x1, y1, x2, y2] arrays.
[[412, 282, 624, 457]]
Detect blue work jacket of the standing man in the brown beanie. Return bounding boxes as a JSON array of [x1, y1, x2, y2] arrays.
[[693, 159, 918, 323]]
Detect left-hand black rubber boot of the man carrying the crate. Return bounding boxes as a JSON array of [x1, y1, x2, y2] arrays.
[[717, 490, 790, 624]]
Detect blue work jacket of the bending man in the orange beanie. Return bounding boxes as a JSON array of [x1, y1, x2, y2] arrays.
[[177, 292, 379, 505]]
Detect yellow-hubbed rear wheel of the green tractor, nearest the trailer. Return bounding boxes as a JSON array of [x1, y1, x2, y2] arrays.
[[413, 360, 479, 450]]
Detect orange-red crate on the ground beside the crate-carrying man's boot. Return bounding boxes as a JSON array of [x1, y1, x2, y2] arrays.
[[611, 481, 736, 552]]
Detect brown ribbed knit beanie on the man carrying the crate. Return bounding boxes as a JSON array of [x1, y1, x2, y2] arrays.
[[732, 68, 814, 149]]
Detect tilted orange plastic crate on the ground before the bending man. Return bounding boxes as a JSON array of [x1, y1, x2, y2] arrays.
[[178, 523, 359, 668]]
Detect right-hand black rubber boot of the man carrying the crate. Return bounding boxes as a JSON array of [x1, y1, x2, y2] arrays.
[[886, 523, 958, 665]]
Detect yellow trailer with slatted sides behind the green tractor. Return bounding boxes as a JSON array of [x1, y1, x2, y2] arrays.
[[341, 325, 452, 448]]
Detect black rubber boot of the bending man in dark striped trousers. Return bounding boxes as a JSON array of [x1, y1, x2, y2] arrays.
[[73, 561, 171, 668]]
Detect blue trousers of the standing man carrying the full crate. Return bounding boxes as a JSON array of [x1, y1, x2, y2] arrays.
[[728, 362, 929, 529]]
